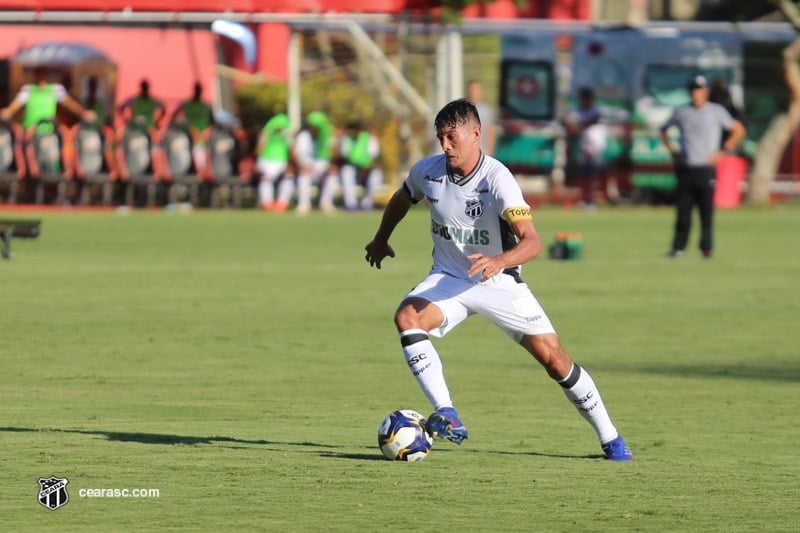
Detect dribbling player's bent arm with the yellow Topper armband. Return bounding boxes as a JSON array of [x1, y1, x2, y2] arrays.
[[467, 206, 542, 281]]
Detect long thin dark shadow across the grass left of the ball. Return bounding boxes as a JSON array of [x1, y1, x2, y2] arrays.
[[0, 427, 339, 448]]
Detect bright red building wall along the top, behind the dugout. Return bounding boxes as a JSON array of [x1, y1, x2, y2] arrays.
[[0, 0, 590, 93]]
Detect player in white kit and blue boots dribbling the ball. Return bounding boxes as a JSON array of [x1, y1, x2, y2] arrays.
[[365, 99, 632, 461]]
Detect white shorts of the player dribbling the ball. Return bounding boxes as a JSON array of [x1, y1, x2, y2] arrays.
[[406, 272, 556, 343]]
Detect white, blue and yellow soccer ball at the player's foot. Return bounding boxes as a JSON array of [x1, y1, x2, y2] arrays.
[[378, 409, 433, 461]]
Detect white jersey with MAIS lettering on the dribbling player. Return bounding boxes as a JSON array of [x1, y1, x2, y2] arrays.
[[403, 154, 530, 282]]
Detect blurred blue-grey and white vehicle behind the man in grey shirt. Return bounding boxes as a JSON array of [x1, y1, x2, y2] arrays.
[[571, 26, 743, 202]]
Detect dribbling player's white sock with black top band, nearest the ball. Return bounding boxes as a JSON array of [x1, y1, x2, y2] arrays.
[[400, 329, 453, 410]]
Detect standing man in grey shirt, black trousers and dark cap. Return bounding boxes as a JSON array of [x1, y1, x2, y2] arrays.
[[661, 76, 745, 258]]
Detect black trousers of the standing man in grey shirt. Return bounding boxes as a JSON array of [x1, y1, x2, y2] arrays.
[[672, 166, 717, 252]]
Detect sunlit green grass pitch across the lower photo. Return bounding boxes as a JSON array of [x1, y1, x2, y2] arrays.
[[0, 205, 800, 532]]
